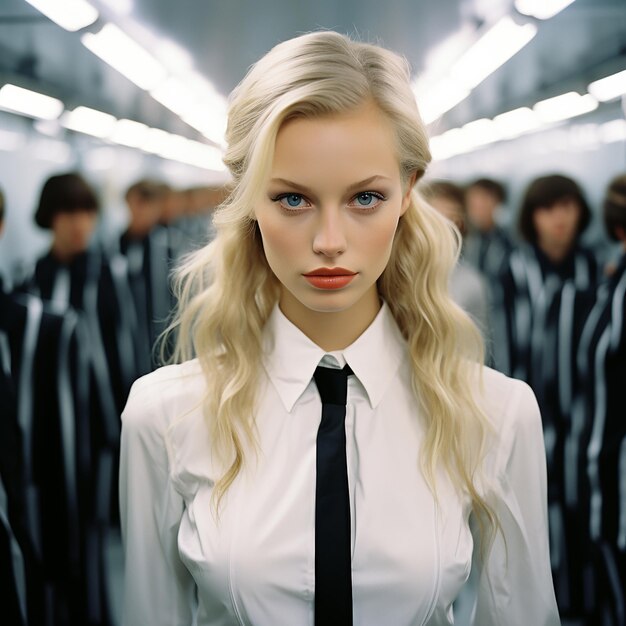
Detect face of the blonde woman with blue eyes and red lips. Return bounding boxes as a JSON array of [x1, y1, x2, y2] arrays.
[[255, 104, 411, 323]]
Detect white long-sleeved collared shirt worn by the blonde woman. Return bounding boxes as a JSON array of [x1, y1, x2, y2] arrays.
[[120, 305, 560, 626]]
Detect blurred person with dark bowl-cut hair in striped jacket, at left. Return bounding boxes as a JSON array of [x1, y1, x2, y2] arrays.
[[15, 172, 137, 620]]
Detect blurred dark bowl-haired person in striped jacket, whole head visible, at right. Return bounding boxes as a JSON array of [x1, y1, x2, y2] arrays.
[[494, 174, 598, 607]]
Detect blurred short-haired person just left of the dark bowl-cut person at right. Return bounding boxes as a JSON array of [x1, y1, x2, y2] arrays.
[[464, 178, 513, 279]]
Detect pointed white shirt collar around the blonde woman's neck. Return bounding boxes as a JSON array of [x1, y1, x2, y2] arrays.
[[263, 302, 406, 411]]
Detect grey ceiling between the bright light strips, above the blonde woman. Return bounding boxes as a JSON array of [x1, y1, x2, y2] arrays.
[[0, 0, 626, 137]]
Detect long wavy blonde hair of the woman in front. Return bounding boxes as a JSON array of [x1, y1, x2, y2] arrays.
[[171, 32, 497, 540]]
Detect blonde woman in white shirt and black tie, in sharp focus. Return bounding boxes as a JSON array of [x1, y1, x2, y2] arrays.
[[121, 32, 559, 626]]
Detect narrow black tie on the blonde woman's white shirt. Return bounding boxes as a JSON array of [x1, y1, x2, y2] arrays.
[[313, 365, 353, 626]]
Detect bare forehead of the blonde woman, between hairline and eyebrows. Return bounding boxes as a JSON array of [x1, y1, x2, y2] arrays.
[[271, 103, 400, 185]]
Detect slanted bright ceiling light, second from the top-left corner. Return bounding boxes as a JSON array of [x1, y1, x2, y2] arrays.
[[81, 24, 166, 89]]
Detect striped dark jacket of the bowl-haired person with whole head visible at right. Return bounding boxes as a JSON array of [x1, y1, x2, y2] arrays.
[[494, 245, 597, 607]]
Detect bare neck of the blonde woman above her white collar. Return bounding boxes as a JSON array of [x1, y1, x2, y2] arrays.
[[279, 287, 381, 352]]
